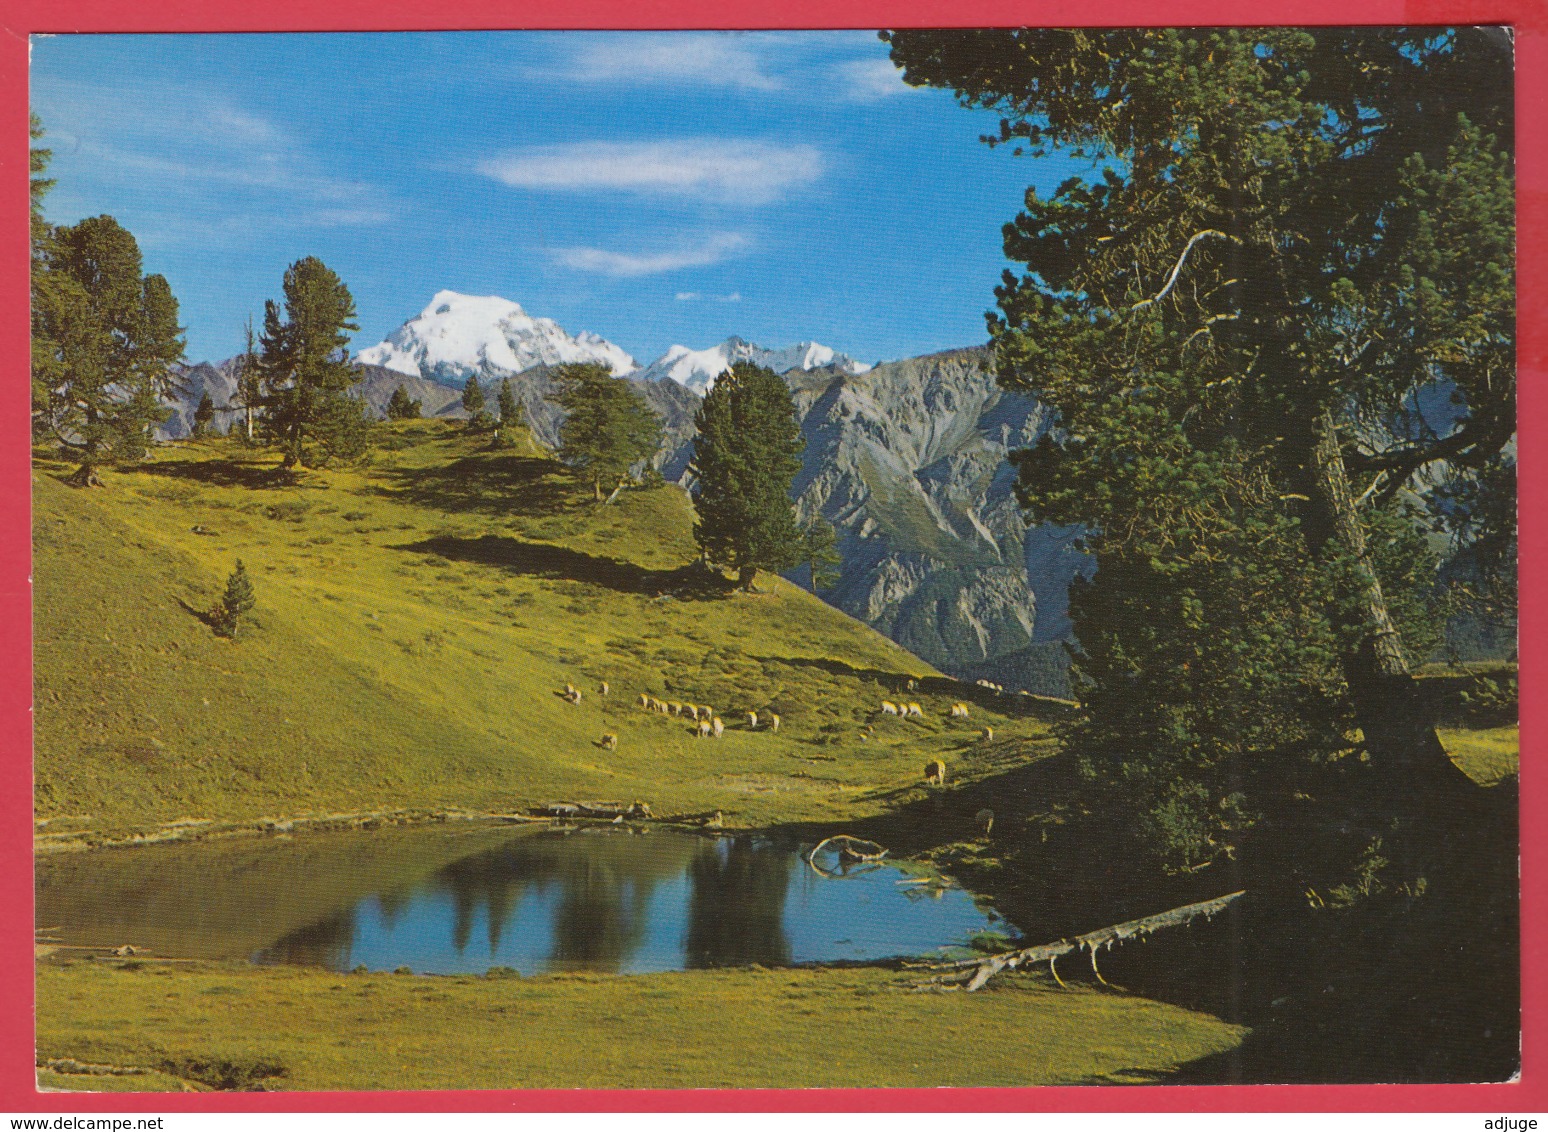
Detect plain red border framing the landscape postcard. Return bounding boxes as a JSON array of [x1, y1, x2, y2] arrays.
[[0, 0, 1548, 1113]]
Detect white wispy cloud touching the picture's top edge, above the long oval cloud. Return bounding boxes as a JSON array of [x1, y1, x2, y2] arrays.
[[562, 33, 785, 90]]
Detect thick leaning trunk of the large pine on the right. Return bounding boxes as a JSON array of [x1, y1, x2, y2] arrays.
[[1303, 413, 1471, 793]]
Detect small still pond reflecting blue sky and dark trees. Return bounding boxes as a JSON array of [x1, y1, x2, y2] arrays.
[[39, 828, 989, 974]]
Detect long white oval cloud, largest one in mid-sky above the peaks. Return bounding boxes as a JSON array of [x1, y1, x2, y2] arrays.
[[478, 138, 825, 204]]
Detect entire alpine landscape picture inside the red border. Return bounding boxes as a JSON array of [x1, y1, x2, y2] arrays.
[[31, 26, 1522, 1092]]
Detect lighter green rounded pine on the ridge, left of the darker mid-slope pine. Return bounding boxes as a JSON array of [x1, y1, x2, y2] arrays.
[[554, 364, 661, 503]]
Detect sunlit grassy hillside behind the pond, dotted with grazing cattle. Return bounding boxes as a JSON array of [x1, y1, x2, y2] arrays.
[[33, 421, 1043, 836]]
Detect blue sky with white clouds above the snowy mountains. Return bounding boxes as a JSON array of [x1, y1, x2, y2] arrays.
[[33, 31, 1076, 364]]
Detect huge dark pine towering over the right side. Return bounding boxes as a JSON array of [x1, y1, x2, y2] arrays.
[[885, 28, 1515, 852]]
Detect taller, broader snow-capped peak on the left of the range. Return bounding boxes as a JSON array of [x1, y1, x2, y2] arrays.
[[359, 291, 639, 384]]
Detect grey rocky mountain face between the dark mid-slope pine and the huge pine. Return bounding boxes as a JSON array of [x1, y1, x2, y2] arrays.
[[774, 348, 1085, 691]]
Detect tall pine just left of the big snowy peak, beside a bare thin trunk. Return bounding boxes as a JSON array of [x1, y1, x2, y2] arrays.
[[259, 256, 370, 468]]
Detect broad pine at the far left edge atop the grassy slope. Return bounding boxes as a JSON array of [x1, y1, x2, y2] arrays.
[[33, 215, 184, 485]]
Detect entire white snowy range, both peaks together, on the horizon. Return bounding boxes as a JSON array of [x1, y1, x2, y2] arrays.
[[358, 291, 870, 393]]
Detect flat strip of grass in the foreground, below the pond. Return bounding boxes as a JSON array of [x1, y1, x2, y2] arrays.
[[37, 963, 1246, 1090]]
